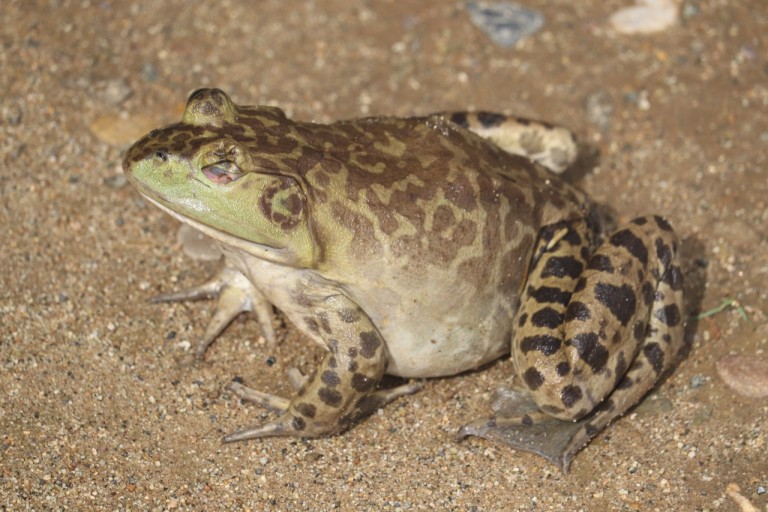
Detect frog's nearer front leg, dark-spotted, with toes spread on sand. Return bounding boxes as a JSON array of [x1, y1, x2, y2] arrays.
[[224, 295, 421, 442]]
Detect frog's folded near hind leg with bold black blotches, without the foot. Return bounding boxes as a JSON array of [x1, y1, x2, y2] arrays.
[[513, 217, 682, 423]]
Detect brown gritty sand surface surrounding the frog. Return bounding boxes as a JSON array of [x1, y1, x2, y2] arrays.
[[0, 0, 768, 511]]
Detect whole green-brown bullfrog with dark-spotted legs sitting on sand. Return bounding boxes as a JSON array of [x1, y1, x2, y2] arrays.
[[123, 88, 685, 471]]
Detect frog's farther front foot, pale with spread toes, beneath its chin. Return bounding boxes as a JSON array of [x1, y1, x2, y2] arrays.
[[152, 259, 277, 359]]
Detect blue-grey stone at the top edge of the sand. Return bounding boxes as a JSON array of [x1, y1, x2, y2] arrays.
[[467, 2, 544, 48]]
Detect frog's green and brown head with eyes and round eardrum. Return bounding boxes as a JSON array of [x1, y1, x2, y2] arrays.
[[123, 89, 315, 266]]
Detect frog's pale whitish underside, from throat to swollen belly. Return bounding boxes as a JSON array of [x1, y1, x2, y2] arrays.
[[222, 245, 511, 378]]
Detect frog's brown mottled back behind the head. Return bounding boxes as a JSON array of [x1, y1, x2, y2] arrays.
[[299, 115, 587, 265]]
